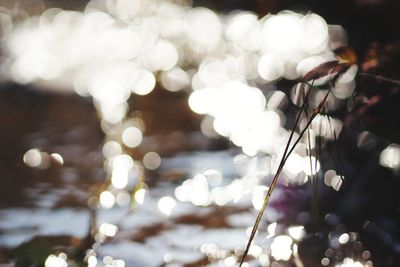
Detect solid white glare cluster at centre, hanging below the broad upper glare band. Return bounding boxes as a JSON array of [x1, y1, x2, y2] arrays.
[[189, 81, 281, 156]]
